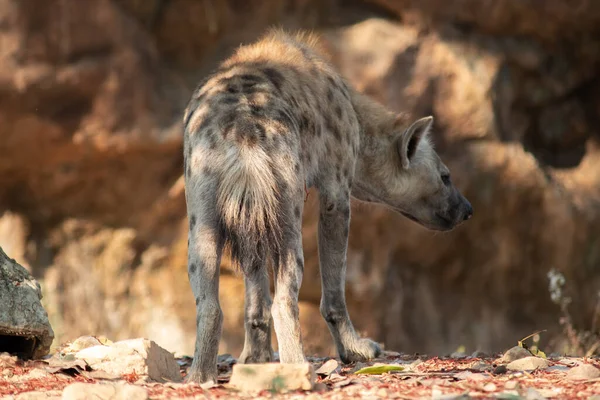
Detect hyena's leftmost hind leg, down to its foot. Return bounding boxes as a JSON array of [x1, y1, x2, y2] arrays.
[[186, 177, 224, 383]]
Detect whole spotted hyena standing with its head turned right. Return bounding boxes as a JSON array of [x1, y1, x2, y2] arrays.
[[184, 30, 472, 382]]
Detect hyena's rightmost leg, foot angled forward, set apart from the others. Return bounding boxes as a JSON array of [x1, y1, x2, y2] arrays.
[[319, 193, 381, 363]]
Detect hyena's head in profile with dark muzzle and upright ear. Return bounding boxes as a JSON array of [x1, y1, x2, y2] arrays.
[[352, 117, 473, 231]]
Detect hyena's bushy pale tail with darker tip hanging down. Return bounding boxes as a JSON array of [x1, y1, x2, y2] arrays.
[[217, 147, 284, 272]]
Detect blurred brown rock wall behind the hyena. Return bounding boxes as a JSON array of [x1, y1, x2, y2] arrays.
[[0, 0, 600, 356]]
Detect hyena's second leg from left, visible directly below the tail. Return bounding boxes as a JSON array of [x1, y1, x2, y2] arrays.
[[238, 268, 273, 364]]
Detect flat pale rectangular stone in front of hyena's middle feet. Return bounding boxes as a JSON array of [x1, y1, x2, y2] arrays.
[[229, 363, 316, 393]]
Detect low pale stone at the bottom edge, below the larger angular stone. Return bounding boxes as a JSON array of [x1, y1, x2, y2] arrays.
[[62, 382, 148, 400]]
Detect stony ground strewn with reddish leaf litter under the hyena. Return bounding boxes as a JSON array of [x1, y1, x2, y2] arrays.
[[0, 352, 600, 400]]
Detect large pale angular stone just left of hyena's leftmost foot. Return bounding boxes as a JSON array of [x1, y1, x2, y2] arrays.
[[75, 339, 182, 382]]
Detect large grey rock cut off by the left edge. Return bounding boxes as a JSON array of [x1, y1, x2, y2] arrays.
[[0, 248, 54, 359]]
